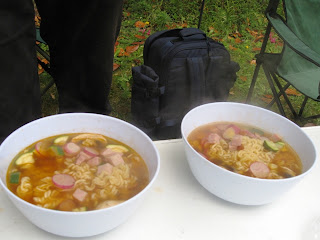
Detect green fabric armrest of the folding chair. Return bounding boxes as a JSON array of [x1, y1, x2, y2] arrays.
[[266, 13, 320, 67]]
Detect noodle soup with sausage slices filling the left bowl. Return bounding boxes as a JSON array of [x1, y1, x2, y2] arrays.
[[7, 133, 149, 211]]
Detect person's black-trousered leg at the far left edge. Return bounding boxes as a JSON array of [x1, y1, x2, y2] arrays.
[[0, 0, 41, 142]]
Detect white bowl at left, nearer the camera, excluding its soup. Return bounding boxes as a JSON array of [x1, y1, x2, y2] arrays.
[[0, 113, 160, 237]]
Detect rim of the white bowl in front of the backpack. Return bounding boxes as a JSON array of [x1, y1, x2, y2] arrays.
[[181, 102, 318, 183]]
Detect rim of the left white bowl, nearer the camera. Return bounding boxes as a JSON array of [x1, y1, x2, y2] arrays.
[[0, 113, 160, 215]]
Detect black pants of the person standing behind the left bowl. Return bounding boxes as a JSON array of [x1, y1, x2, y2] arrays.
[[0, 0, 123, 142]]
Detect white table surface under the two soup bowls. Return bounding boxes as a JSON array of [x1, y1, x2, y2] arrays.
[[0, 127, 320, 240]]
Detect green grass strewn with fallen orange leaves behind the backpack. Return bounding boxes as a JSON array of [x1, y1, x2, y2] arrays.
[[40, 0, 320, 126]]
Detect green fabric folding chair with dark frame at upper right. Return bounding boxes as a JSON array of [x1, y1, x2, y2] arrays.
[[246, 0, 320, 120]]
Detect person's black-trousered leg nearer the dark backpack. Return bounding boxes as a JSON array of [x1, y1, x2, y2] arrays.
[[37, 0, 123, 114]]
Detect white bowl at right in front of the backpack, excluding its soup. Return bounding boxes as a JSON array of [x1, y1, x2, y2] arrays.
[[181, 102, 317, 205]]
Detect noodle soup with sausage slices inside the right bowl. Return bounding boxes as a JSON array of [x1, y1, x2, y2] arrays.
[[188, 122, 302, 179]]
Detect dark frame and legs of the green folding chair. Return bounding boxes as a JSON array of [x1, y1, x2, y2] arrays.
[[246, 0, 320, 120]]
